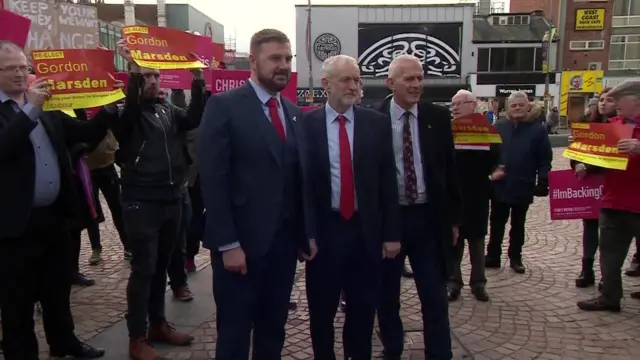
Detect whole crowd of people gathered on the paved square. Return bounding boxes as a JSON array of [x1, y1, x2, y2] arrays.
[[0, 29, 640, 360]]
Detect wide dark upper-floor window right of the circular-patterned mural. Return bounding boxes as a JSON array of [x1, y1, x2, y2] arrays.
[[478, 47, 542, 72]]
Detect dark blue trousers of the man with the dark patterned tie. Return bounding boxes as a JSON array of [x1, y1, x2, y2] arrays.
[[378, 204, 453, 360]]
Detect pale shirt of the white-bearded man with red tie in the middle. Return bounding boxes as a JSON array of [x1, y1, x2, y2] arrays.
[[324, 103, 358, 210]]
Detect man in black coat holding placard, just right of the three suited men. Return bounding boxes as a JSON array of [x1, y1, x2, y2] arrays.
[[449, 90, 504, 301]]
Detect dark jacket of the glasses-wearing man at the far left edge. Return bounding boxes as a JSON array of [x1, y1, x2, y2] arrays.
[[0, 102, 114, 239]]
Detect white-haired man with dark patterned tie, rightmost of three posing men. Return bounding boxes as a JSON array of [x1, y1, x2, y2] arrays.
[[378, 55, 462, 359]]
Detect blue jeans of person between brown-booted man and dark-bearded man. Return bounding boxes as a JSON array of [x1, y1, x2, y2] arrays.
[[167, 186, 192, 290]]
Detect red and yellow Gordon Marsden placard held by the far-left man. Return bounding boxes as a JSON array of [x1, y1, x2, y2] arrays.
[[32, 49, 124, 111]]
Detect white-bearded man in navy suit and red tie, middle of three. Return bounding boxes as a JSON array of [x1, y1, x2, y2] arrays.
[[303, 55, 400, 360]]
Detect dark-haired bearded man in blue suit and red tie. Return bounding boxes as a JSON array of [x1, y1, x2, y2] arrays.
[[198, 29, 316, 360]]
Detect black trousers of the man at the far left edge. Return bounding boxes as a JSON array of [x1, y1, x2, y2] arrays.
[[0, 207, 80, 360]]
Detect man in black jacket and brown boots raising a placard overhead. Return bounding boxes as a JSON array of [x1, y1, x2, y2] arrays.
[[113, 40, 205, 360]]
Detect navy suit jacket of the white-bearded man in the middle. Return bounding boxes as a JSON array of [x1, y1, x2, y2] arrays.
[[303, 106, 400, 258]]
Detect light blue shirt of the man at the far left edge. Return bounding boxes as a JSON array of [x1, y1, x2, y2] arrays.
[[0, 91, 61, 207]]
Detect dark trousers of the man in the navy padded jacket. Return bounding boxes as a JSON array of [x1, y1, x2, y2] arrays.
[[487, 200, 529, 261]]
